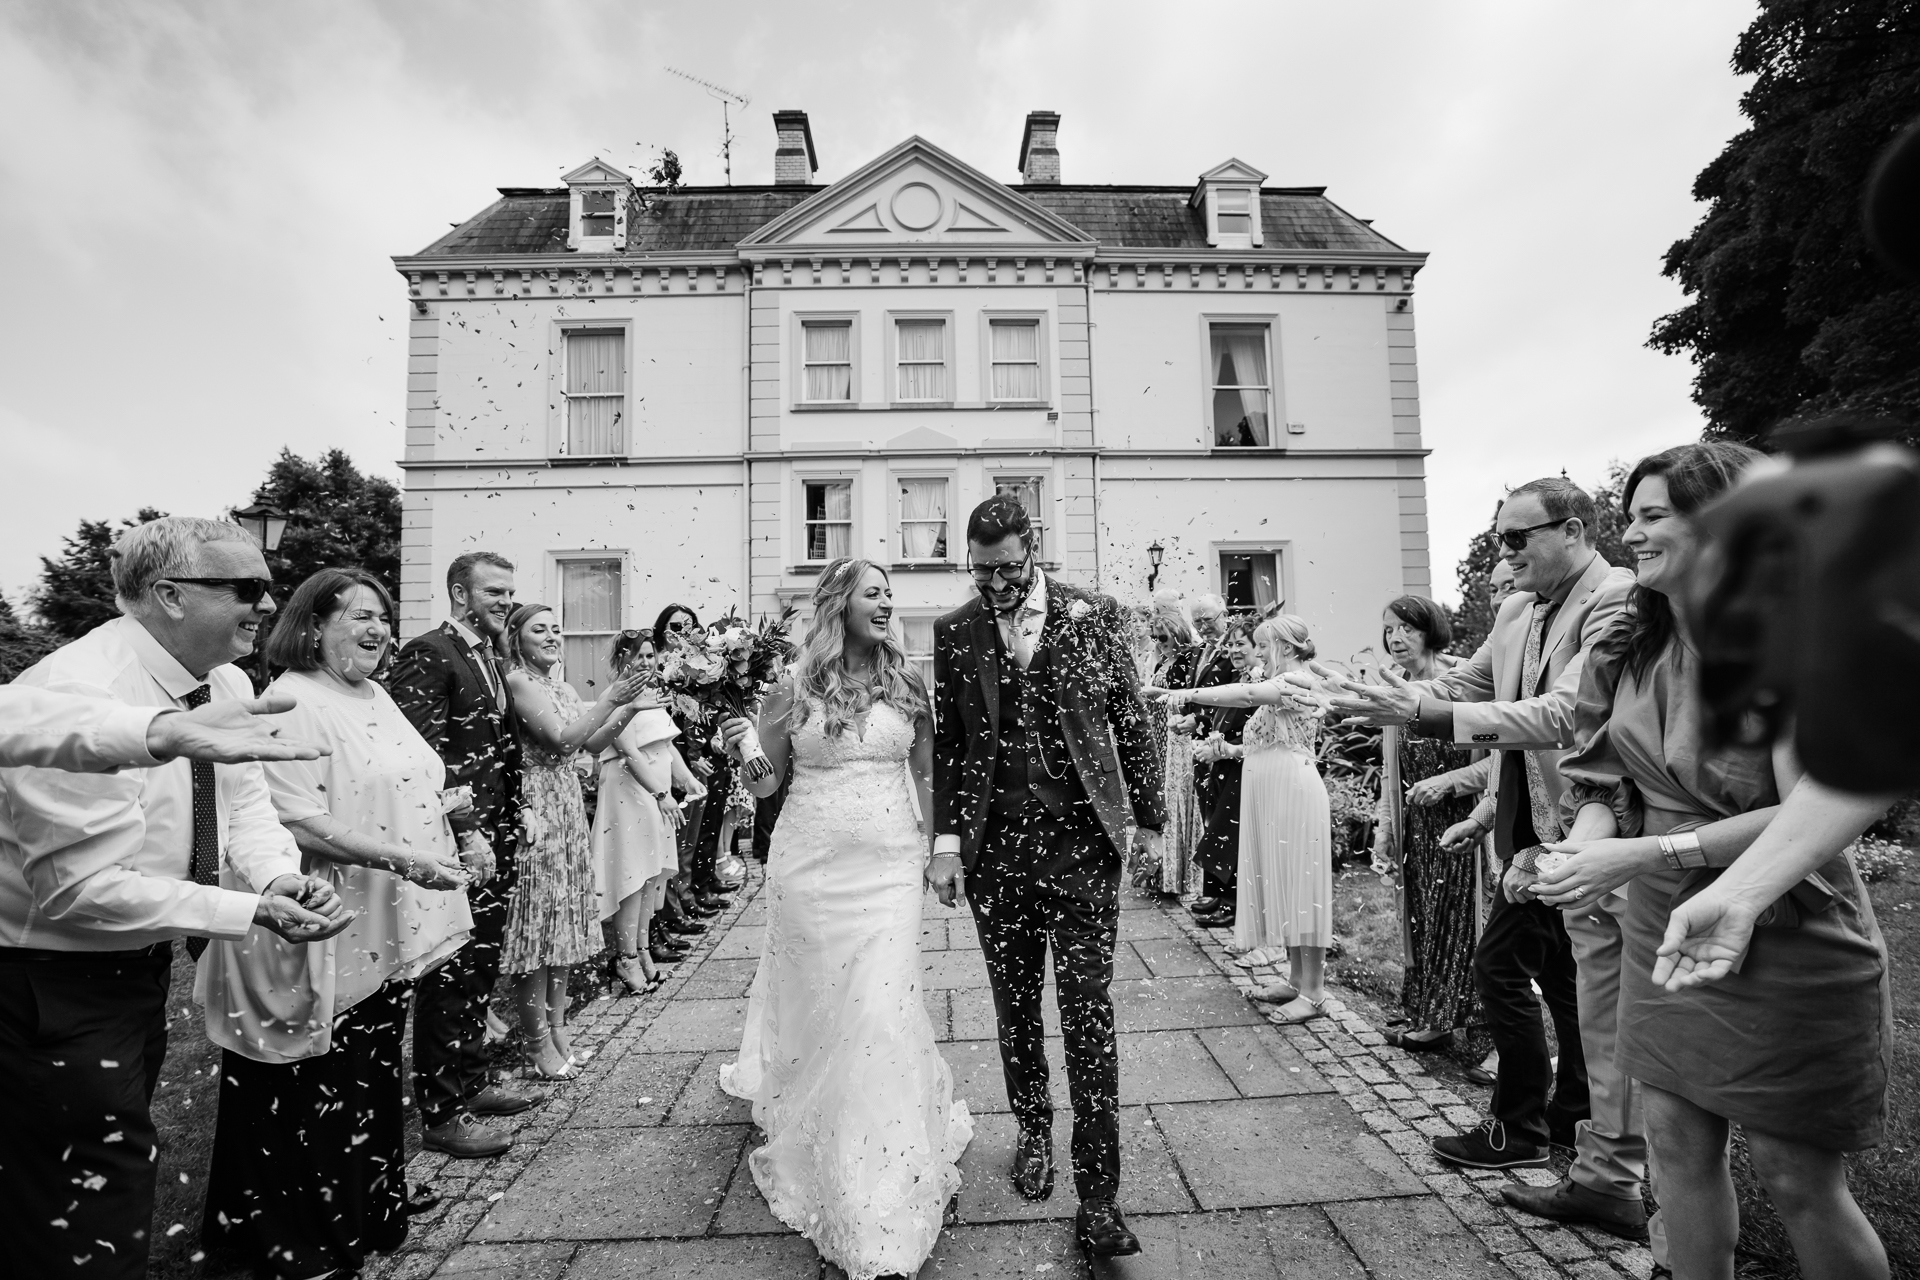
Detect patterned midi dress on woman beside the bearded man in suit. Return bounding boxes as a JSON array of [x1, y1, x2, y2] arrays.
[[499, 672, 601, 973]]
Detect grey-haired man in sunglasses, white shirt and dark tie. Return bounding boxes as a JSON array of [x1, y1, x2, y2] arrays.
[[0, 516, 351, 1280]]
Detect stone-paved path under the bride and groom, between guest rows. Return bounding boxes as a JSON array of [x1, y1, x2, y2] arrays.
[[367, 881, 1651, 1280]]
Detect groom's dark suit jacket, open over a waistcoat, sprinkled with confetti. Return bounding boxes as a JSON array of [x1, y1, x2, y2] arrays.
[[933, 578, 1164, 871]]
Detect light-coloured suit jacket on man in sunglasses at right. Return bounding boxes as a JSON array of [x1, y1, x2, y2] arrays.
[[1413, 555, 1634, 836]]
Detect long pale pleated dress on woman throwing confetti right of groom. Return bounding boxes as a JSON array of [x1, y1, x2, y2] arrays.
[[1233, 704, 1332, 950]]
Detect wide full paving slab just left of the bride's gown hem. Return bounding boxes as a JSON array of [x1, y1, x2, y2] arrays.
[[472, 1125, 749, 1240]]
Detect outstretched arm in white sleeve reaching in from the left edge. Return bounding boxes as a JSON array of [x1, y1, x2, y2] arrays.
[[0, 683, 326, 773]]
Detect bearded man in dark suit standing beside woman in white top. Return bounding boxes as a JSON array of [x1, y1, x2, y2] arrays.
[[388, 551, 540, 1157]]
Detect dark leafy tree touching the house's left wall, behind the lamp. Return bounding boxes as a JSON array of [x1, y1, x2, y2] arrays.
[[253, 449, 399, 599]]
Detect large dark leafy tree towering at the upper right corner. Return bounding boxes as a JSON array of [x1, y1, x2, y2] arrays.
[[1647, 0, 1920, 441]]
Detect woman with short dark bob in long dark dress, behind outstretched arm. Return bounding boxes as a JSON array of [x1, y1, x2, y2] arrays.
[[1373, 595, 1478, 1052]]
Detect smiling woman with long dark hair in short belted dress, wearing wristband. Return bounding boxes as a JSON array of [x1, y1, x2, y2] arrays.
[[1532, 441, 1891, 1280]]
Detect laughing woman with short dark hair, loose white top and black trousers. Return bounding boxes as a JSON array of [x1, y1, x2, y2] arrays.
[[194, 568, 472, 1278]]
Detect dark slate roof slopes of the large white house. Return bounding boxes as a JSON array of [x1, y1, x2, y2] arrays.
[[408, 184, 1402, 257]]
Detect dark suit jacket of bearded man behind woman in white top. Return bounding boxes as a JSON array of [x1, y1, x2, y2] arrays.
[[386, 624, 520, 860]]
